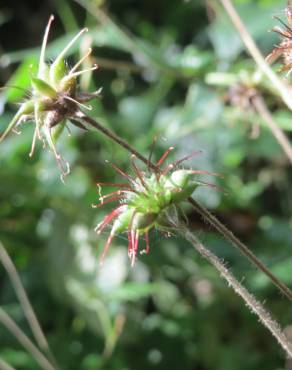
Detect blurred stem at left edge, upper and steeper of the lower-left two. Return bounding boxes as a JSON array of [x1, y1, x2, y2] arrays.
[[0, 241, 58, 368]]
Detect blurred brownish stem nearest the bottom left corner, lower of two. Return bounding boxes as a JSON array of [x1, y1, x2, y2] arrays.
[[0, 307, 55, 370]]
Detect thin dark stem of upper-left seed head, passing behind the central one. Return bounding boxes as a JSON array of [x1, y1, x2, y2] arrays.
[[80, 115, 292, 300]]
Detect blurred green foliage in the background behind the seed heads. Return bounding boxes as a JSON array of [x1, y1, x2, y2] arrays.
[[0, 0, 292, 370]]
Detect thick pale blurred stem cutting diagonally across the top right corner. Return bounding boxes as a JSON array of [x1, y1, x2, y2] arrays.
[[219, 0, 292, 109]]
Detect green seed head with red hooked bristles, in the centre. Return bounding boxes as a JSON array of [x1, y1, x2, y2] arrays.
[[93, 147, 218, 266]]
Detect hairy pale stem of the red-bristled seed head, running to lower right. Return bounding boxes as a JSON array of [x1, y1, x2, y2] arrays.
[[179, 225, 292, 358]]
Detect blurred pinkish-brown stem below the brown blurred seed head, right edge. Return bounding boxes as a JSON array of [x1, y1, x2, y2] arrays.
[[252, 96, 292, 163]]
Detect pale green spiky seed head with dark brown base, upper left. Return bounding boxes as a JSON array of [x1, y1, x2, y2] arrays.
[[0, 16, 100, 180]]
